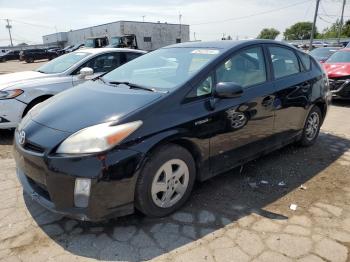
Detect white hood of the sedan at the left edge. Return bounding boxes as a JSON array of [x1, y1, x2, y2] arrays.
[[0, 71, 48, 90]]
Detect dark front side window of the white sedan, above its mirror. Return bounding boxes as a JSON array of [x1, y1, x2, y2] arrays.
[[75, 53, 121, 74]]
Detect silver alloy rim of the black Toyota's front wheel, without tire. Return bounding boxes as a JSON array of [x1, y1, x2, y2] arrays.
[[151, 159, 189, 208]]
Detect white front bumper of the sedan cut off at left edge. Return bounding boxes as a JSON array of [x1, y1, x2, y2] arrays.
[[0, 99, 27, 129]]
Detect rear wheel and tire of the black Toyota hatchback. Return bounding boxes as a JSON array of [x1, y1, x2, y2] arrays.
[[299, 106, 323, 147]]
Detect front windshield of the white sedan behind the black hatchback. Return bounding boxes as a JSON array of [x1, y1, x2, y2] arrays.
[[36, 52, 90, 74]]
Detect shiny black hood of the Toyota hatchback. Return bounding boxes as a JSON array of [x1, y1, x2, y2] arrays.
[[30, 81, 162, 133]]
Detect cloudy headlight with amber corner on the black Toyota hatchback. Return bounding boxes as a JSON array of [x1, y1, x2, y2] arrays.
[[56, 121, 142, 154]]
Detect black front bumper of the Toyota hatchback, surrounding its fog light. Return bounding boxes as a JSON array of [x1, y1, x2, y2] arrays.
[[14, 139, 143, 222]]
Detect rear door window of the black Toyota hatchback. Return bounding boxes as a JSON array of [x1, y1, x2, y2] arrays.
[[269, 47, 300, 79]]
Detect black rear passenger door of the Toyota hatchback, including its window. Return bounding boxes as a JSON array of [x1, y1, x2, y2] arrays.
[[268, 45, 312, 141]]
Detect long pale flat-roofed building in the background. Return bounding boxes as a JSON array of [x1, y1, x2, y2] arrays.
[[43, 21, 190, 50]]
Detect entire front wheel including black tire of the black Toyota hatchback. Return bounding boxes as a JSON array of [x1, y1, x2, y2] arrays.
[[135, 144, 196, 217]]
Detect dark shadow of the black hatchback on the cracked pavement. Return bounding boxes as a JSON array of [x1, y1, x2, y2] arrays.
[[24, 133, 350, 261]]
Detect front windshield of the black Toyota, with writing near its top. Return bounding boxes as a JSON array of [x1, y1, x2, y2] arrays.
[[103, 47, 220, 89]]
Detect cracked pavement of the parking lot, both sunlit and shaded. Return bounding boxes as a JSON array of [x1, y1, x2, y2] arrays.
[[0, 62, 350, 262]]
